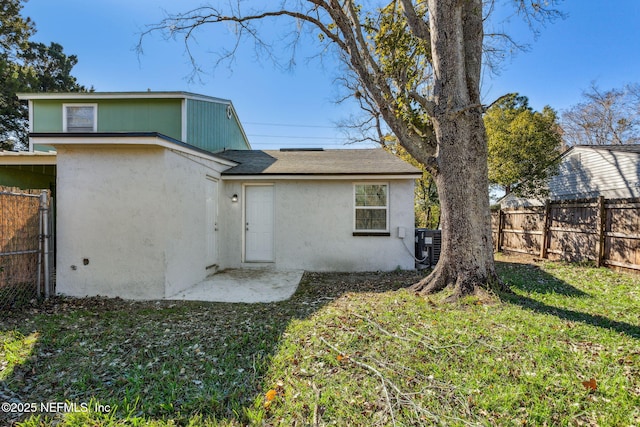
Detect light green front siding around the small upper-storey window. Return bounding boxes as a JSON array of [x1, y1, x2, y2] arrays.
[[33, 98, 182, 140]]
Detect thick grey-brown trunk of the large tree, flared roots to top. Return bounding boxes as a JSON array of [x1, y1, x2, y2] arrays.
[[413, 0, 507, 298]]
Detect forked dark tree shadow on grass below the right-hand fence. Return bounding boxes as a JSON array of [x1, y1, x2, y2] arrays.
[[496, 262, 640, 339]]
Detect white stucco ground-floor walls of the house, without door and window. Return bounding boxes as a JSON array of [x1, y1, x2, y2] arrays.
[[56, 142, 414, 299]]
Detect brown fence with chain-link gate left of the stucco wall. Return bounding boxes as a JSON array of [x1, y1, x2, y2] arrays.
[[0, 187, 53, 311]]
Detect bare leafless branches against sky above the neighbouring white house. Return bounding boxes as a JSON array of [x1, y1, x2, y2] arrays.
[[562, 84, 640, 145]]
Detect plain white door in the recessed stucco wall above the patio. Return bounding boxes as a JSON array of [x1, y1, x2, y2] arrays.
[[244, 185, 274, 262]]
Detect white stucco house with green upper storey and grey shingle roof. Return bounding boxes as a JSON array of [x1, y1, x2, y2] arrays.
[[7, 92, 421, 299]]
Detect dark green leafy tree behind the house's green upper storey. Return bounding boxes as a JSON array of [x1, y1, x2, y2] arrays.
[[0, 0, 86, 149]]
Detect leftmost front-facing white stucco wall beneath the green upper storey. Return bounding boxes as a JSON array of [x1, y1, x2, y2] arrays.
[[56, 146, 165, 299]]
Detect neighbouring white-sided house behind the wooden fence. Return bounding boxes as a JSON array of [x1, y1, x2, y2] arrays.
[[498, 145, 640, 208]]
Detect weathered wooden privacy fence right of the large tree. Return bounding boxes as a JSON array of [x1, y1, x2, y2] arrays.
[[491, 197, 640, 270]]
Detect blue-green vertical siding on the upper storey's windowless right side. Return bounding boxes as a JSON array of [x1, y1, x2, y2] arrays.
[[186, 99, 249, 153]]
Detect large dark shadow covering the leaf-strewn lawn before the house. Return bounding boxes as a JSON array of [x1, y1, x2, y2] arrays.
[[0, 272, 420, 425]]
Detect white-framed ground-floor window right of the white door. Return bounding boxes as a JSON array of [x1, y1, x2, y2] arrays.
[[354, 183, 389, 233]]
